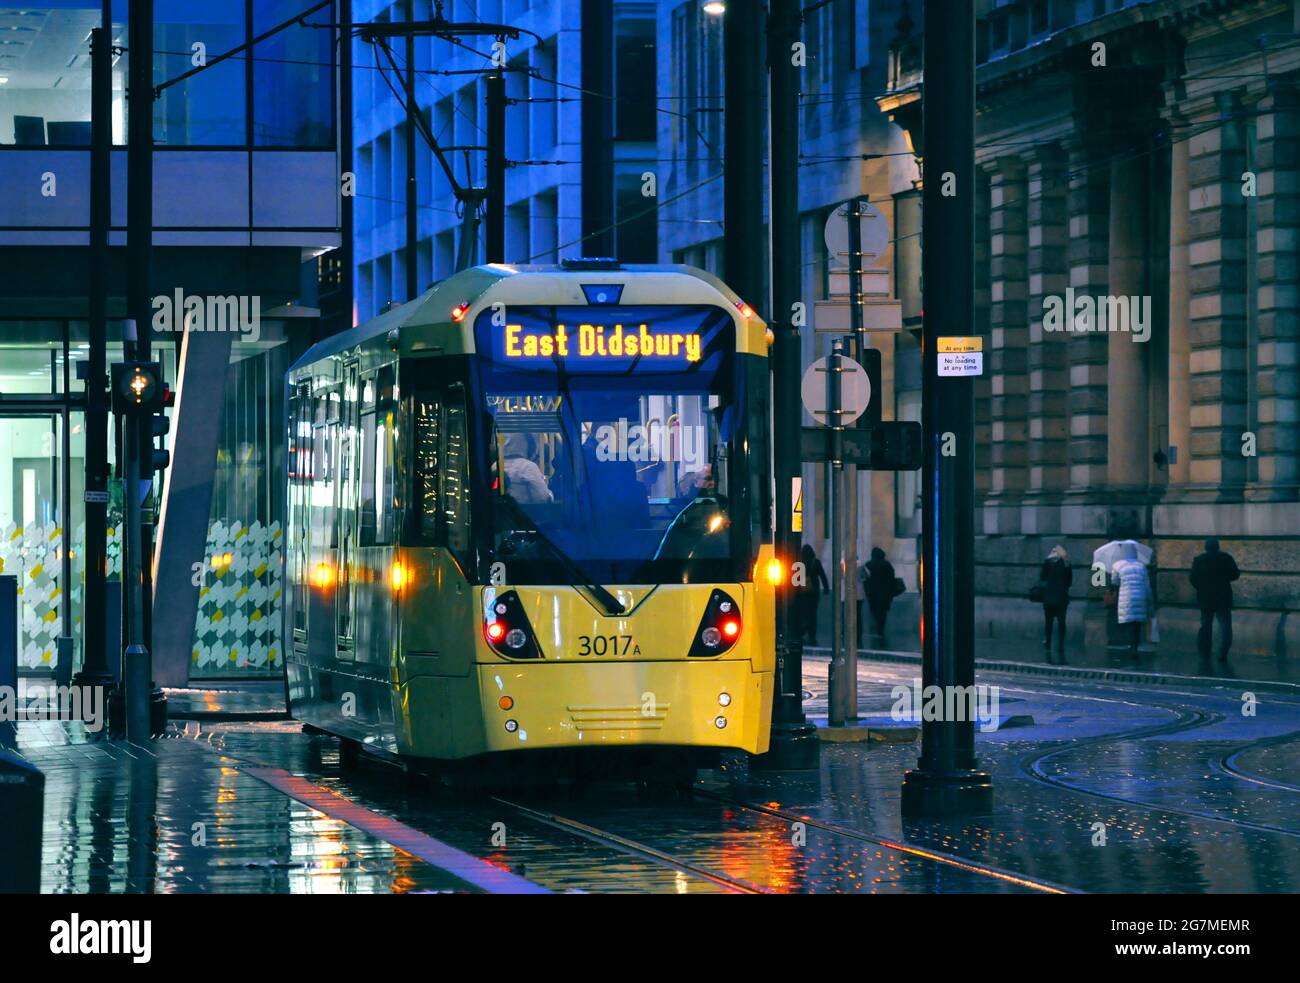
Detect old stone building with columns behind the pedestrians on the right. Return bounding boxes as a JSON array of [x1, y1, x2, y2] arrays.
[[878, 0, 1300, 655]]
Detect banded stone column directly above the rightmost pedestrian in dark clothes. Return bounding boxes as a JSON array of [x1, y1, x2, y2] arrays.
[[1188, 92, 1247, 501]]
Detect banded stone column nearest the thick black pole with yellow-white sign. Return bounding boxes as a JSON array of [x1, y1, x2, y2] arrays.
[[984, 157, 1028, 533]]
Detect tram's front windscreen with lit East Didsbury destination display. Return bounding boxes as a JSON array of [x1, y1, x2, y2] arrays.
[[475, 306, 766, 584]]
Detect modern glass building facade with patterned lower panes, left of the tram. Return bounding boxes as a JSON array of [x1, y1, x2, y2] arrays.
[[0, 0, 342, 677]]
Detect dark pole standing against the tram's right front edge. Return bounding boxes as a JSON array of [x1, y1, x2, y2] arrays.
[[754, 0, 820, 768]]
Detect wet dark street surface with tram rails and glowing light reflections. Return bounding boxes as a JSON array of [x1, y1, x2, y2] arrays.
[[20, 662, 1300, 893]]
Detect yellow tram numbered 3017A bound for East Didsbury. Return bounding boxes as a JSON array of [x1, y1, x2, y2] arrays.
[[283, 260, 781, 767]]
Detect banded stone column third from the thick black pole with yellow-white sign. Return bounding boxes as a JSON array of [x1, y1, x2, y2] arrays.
[[1066, 134, 1110, 497]]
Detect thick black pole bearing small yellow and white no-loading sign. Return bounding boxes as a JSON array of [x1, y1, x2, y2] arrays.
[[902, 0, 993, 815]]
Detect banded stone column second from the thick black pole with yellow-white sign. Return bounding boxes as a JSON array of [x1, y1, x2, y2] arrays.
[[1026, 144, 1070, 499]]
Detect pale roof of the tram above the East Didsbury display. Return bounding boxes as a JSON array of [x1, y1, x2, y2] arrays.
[[290, 263, 767, 372]]
